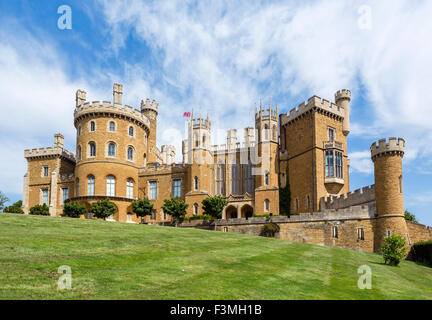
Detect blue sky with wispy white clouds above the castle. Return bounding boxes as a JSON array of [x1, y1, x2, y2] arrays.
[[0, 0, 432, 225]]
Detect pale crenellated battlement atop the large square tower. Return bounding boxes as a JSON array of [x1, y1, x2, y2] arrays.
[[281, 96, 345, 125]]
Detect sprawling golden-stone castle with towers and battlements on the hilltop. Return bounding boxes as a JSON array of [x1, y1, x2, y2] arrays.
[[23, 83, 432, 252]]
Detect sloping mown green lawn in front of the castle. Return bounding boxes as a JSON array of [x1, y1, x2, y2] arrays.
[[0, 214, 432, 299]]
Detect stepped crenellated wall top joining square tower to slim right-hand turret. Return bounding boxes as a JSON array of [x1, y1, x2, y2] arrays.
[[320, 185, 375, 210]]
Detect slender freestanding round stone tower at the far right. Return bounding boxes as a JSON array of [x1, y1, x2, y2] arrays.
[[371, 138, 408, 252]]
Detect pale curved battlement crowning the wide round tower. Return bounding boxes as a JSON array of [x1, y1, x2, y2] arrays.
[[74, 101, 150, 131]]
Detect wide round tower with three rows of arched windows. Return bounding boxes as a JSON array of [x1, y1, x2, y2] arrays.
[[71, 84, 150, 222]]
